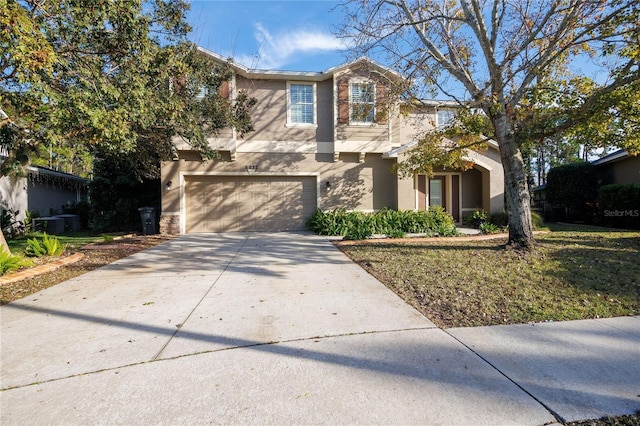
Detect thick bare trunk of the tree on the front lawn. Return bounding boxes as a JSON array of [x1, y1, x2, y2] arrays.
[[493, 114, 533, 248]]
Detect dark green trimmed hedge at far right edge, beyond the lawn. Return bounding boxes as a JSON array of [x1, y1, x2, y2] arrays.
[[598, 183, 640, 229]]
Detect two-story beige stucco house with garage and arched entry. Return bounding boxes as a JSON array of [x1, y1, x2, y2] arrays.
[[160, 49, 504, 234]]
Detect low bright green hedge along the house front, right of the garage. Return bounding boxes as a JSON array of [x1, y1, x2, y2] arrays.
[[307, 207, 458, 240]]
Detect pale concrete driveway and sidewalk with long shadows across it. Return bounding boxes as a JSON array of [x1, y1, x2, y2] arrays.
[[0, 233, 640, 425]]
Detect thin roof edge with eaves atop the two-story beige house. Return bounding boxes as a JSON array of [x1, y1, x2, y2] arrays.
[[198, 47, 404, 81]]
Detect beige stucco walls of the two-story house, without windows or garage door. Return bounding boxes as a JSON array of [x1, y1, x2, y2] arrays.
[[160, 53, 504, 233]]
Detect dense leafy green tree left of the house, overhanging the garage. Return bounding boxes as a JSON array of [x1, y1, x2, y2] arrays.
[[0, 0, 255, 236]]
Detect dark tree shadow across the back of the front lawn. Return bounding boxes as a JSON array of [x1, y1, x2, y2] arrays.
[[344, 230, 640, 304]]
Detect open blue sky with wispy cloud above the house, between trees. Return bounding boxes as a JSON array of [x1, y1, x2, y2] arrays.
[[187, 0, 347, 71]]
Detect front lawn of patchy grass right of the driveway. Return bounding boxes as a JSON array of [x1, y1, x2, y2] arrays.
[[340, 225, 640, 328]]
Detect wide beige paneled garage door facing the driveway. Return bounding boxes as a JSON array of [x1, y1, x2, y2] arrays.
[[185, 176, 317, 232]]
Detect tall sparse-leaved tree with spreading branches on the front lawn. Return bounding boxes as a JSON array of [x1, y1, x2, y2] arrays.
[[342, 0, 640, 247]]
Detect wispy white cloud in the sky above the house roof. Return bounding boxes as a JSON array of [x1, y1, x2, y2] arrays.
[[236, 24, 346, 69]]
